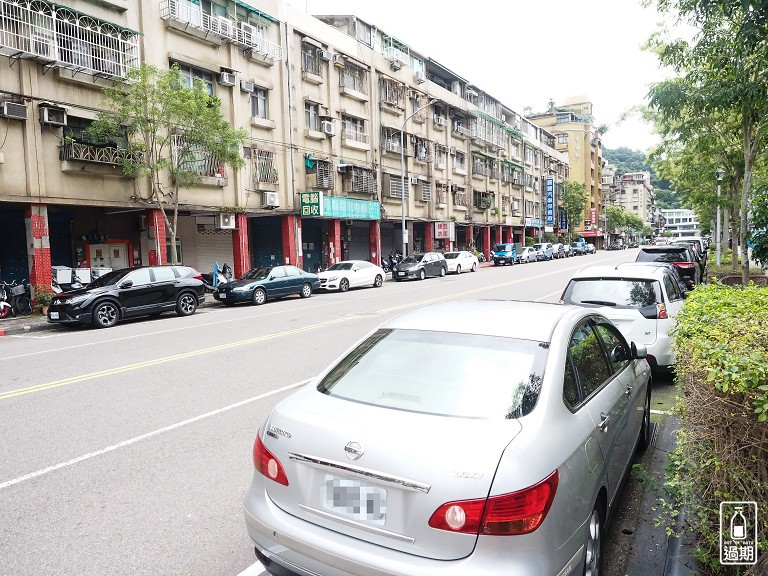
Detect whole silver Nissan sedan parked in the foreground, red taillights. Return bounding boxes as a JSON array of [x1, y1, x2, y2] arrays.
[[244, 300, 650, 576]]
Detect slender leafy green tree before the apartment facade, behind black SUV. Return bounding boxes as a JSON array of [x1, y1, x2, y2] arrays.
[[89, 64, 247, 264]]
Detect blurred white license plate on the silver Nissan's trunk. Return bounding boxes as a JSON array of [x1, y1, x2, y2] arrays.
[[323, 474, 387, 525]]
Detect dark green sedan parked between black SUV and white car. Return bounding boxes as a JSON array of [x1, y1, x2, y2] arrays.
[[213, 265, 320, 306]]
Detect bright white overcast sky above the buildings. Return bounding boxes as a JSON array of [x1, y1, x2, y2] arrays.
[[288, 0, 664, 152]]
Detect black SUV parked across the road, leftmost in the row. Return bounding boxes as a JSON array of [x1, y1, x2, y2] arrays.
[[48, 266, 205, 328]]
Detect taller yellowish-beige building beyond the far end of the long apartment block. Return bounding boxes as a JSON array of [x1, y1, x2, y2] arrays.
[[529, 96, 604, 244]]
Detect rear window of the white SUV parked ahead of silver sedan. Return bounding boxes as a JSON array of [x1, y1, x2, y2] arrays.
[[563, 278, 663, 308]]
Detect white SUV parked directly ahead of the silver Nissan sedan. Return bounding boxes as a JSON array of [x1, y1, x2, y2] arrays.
[[561, 264, 686, 372]]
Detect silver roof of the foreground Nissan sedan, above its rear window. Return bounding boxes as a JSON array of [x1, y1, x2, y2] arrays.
[[382, 300, 594, 342]]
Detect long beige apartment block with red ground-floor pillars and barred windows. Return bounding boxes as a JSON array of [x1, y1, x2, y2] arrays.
[[0, 0, 569, 284]]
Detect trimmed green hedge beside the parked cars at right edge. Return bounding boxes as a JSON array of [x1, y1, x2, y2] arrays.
[[666, 283, 768, 576]]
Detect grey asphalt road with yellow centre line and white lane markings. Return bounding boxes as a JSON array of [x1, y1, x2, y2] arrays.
[[0, 250, 652, 576]]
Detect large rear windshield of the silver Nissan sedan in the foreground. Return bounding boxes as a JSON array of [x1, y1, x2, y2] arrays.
[[318, 330, 549, 419]]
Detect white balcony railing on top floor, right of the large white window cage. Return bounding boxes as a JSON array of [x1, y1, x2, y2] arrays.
[[160, 0, 283, 60]]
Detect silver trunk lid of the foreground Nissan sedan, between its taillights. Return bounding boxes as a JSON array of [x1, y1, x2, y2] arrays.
[[263, 388, 521, 560]]
